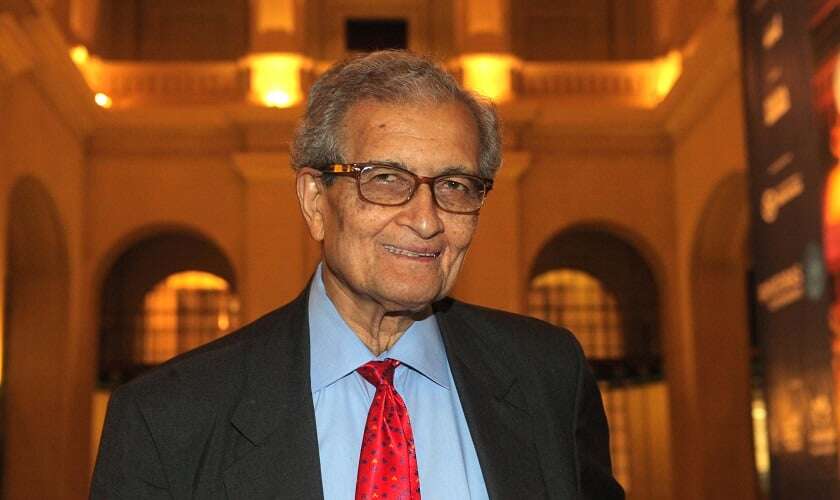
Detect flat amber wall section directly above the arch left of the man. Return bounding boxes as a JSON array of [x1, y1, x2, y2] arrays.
[[86, 153, 244, 290]]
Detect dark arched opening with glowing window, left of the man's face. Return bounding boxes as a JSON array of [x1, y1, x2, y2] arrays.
[[91, 230, 239, 456]]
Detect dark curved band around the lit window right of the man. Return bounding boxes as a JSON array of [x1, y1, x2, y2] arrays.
[[529, 225, 661, 372]]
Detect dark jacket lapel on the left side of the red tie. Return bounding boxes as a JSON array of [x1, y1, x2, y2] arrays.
[[224, 289, 323, 499]]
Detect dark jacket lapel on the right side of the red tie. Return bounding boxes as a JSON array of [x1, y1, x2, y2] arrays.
[[436, 303, 546, 499]]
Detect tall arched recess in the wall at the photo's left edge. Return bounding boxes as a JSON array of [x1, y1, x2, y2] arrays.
[[0, 177, 70, 498]]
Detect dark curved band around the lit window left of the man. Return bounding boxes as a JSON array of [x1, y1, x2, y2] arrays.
[[99, 229, 237, 387]]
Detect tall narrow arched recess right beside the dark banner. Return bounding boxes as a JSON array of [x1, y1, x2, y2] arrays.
[[691, 173, 756, 499]]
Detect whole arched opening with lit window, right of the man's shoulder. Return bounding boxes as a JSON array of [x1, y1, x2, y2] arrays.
[[528, 226, 670, 499]]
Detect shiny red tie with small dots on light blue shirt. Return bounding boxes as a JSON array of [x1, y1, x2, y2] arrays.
[[356, 358, 420, 500]]
